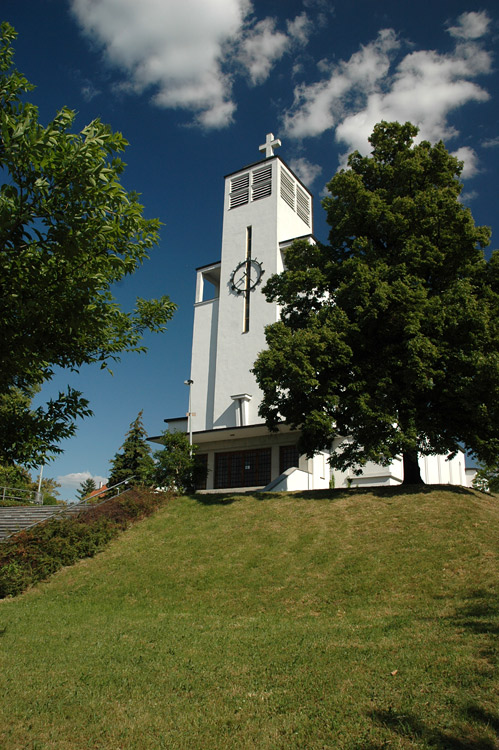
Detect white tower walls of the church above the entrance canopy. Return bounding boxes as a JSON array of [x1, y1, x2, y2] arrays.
[[191, 156, 312, 432]]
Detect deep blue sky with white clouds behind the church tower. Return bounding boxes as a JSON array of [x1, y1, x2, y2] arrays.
[[2, 0, 499, 498]]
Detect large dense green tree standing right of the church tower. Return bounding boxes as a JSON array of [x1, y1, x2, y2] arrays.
[[255, 122, 499, 482]]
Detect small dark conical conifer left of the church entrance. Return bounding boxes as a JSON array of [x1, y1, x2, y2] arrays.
[[108, 412, 154, 487]]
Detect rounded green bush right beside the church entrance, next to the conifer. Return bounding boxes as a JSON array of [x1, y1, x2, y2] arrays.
[[154, 431, 206, 492]]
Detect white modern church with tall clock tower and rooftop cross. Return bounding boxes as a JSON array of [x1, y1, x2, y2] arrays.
[[152, 133, 467, 492]]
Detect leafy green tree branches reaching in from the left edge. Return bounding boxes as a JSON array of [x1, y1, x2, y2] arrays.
[[0, 23, 175, 465]]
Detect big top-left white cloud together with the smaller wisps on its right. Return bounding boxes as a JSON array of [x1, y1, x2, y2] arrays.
[[70, 0, 312, 128]]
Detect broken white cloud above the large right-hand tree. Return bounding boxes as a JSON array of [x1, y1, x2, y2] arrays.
[[284, 13, 492, 176]]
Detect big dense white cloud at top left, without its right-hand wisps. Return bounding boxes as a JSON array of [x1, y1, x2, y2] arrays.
[[71, 0, 252, 127]]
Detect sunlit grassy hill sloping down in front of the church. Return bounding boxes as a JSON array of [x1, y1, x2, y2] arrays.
[[0, 487, 499, 750]]
